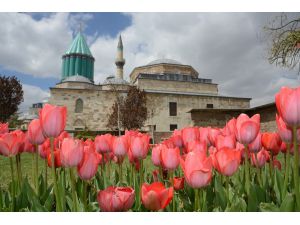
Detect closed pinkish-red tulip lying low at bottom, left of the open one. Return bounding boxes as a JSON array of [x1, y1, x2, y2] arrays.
[[97, 186, 135, 212]]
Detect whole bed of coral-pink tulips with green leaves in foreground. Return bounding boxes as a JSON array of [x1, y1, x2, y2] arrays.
[[0, 87, 300, 212]]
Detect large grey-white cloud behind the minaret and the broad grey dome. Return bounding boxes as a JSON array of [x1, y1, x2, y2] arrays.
[[91, 13, 299, 105]]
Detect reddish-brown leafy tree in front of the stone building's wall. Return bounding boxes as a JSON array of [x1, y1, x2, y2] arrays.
[[107, 86, 147, 130]]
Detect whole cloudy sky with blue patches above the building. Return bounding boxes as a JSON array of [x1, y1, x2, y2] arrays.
[[0, 13, 299, 112]]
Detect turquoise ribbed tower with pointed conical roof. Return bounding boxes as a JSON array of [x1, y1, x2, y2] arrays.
[[62, 32, 95, 82]]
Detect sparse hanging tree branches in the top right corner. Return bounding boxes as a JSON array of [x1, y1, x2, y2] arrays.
[[265, 13, 300, 72]]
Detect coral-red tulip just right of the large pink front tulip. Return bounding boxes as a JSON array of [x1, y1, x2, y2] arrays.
[[212, 147, 241, 176]]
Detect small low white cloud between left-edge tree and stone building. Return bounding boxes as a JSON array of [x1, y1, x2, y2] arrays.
[[19, 84, 50, 112]]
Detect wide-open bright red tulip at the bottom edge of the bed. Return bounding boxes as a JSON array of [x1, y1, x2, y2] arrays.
[[141, 182, 173, 211]]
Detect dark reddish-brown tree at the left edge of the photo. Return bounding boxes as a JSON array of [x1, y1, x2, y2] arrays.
[[0, 76, 23, 122]]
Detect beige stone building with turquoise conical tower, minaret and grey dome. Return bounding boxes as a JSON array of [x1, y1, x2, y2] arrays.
[[49, 33, 255, 141]]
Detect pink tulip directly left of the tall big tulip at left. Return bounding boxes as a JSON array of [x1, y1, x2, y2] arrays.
[[27, 119, 45, 145]]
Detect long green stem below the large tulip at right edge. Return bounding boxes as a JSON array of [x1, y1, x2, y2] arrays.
[[293, 126, 300, 211]]
